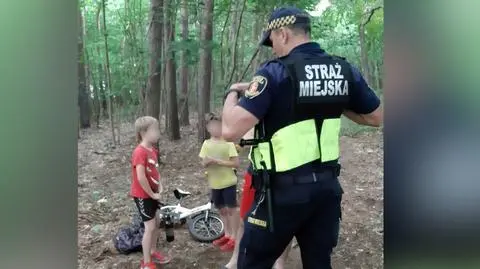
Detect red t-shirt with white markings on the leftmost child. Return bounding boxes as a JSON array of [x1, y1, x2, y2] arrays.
[[130, 145, 160, 198]]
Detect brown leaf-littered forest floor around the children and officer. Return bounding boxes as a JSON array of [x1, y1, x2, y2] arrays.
[[78, 118, 383, 269]]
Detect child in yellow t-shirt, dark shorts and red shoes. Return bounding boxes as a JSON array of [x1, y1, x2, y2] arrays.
[[199, 113, 239, 251]]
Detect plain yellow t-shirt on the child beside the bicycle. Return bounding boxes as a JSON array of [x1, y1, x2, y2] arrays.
[[198, 139, 238, 189]]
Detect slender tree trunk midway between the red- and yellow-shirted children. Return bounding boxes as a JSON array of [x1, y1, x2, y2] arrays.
[[180, 0, 190, 126]]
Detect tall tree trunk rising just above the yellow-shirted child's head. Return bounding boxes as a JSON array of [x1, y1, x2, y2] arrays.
[[198, 0, 214, 141]]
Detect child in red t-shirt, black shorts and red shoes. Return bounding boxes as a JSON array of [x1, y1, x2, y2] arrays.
[[130, 116, 170, 269]]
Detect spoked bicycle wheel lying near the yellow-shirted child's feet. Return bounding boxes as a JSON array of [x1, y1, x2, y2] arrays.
[[188, 212, 224, 243]]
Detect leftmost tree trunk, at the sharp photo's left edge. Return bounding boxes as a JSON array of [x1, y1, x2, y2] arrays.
[[78, 9, 90, 128]]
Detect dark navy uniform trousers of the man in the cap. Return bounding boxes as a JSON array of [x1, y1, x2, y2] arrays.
[[237, 174, 343, 269]]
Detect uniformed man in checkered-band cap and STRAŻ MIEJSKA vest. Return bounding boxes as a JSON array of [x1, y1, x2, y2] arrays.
[[222, 7, 383, 269]]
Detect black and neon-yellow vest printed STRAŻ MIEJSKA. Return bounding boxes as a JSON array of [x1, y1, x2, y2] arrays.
[[249, 53, 353, 172]]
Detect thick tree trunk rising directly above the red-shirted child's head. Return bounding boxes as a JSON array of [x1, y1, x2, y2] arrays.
[[145, 0, 163, 120]]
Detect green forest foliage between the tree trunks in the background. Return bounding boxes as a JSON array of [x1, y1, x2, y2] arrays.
[[80, 0, 383, 135]]
